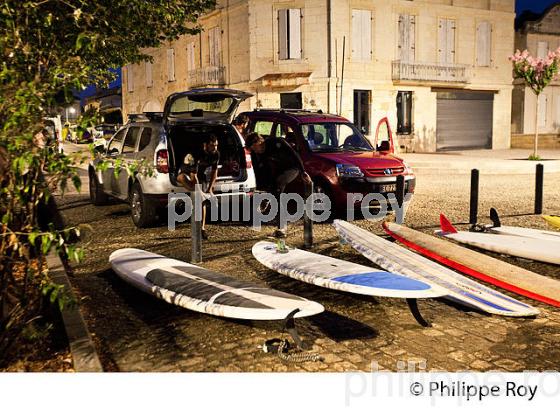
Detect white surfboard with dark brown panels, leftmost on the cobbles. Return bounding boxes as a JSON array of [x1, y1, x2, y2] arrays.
[[109, 248, 324, 320]]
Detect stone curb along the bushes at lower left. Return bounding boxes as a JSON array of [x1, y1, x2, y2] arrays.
[[47, 252, 103, 372]]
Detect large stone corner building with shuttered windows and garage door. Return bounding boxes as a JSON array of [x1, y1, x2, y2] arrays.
[[123, 0, 515, 152]]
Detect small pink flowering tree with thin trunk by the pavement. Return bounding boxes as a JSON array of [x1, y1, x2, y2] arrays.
[[509, 47, 560, 159]]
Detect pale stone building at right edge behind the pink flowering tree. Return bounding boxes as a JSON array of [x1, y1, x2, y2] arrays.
[[511, 3, 560, 148]]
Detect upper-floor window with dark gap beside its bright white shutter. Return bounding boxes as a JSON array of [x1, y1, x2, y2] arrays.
[[278, 9, 301, 60]]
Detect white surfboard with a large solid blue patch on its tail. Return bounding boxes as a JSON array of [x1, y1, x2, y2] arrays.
[[253, 241, 446, 299]]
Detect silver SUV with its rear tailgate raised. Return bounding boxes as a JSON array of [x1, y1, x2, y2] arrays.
[[89, 88, 256, 228]]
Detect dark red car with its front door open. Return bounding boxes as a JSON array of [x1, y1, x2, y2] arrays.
[[243, 109, 416, 211]]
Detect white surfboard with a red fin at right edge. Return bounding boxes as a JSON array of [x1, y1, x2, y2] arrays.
[[436, 215, 560, 265]]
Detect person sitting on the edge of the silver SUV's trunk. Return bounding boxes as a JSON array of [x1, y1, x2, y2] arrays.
[[177, 135, 220, 239]]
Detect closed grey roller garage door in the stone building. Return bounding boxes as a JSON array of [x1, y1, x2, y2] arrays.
[[436, 91, 494, 151]]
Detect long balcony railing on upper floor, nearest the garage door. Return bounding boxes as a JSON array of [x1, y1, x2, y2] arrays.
[[393, 60, 470, 83]]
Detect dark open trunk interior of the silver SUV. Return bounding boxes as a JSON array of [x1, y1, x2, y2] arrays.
[[168, 123, 246, 185]]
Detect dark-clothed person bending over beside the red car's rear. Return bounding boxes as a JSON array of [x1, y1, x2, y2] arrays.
[[245, 133, 311, 238]]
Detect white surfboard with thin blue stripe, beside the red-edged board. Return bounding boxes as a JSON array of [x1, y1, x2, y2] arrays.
[[334, 220, 539, 316]]
